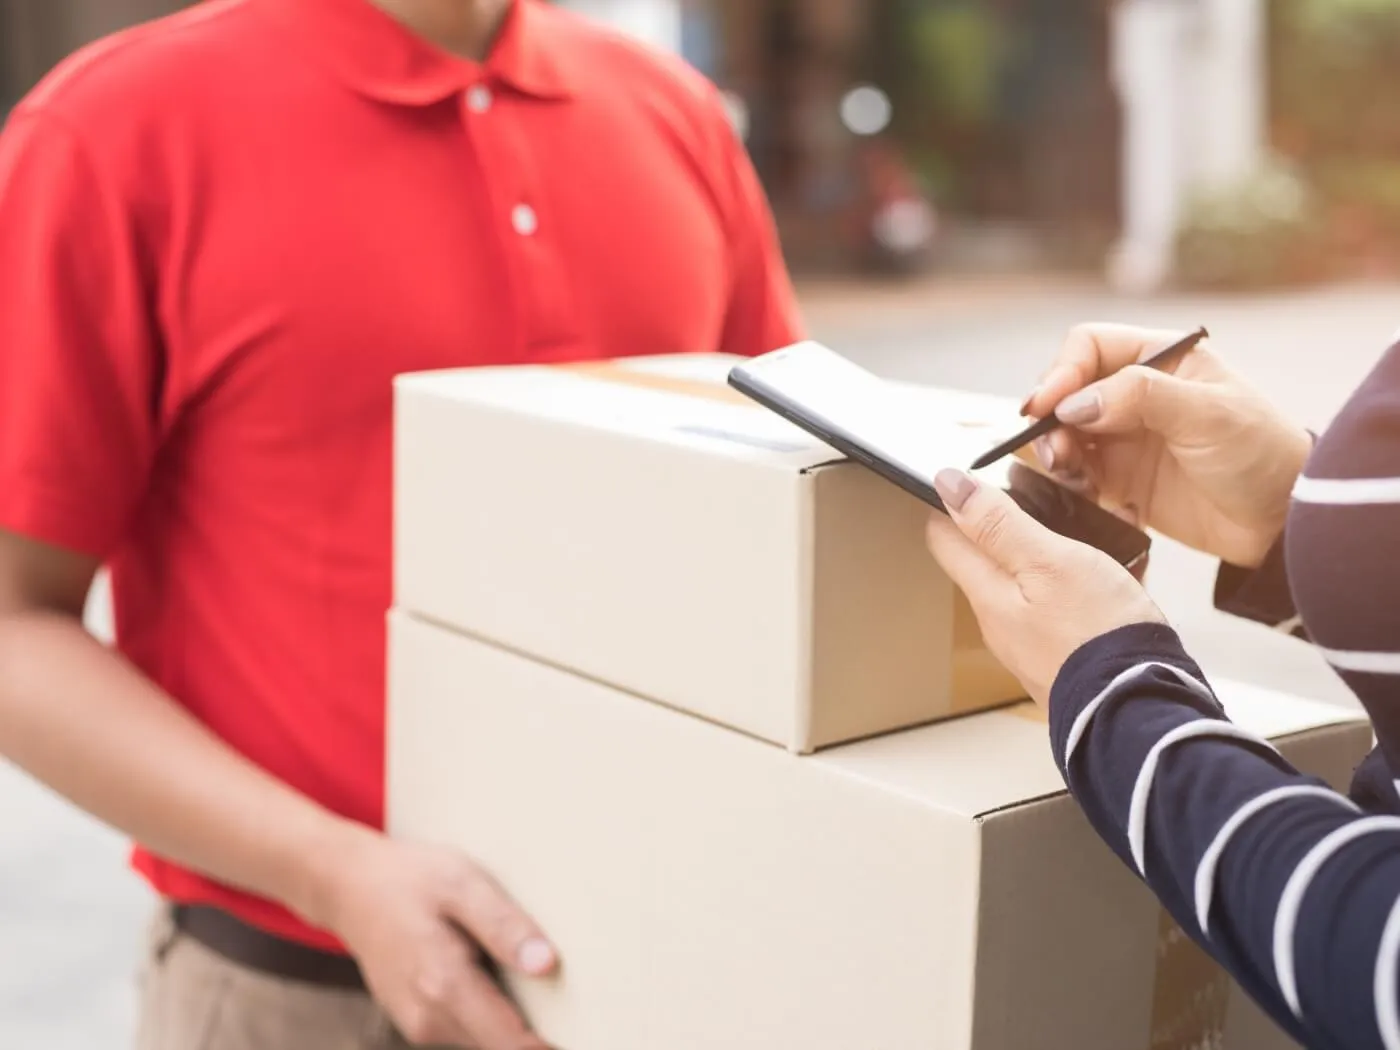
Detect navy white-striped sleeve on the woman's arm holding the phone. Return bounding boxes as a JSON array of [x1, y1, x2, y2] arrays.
[[1050, 624, 1400, 1050]]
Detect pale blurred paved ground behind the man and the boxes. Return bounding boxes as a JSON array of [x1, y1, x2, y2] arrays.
[[0, 281, 1400, 1050]]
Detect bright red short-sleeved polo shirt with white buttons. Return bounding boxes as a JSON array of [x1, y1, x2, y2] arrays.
[[0, 0, 798, 946]]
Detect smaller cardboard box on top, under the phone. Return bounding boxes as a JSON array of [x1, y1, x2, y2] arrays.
[[395, 354, 1023, 753]]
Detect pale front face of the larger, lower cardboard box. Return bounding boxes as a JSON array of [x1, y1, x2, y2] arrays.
[[391, 619, 977, 1050]]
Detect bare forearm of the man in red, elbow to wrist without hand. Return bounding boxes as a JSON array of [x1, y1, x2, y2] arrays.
[[0, 612, 367, 924]]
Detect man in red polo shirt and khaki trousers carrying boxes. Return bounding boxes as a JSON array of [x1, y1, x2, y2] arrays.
[[0, 0, 798, 1050]]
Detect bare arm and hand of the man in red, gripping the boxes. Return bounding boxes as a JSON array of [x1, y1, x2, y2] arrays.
[[0, 531, 556, 1050]]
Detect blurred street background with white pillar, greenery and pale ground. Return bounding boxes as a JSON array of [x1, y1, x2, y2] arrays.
[[8, 0, 1400, 1050]]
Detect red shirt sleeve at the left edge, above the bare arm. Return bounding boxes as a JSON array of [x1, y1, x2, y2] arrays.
[[0, 109, 160, 557]]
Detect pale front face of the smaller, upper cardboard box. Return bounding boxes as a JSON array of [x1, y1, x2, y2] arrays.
[[395, 368, 811, 745]]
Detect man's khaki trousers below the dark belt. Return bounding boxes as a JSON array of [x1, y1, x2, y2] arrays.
[[136, 909, 431, 1050]]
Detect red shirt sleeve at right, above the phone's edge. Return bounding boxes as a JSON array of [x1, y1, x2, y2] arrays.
[[714, 92, 805, 357]]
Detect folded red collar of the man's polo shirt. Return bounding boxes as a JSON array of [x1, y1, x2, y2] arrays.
[[260, 0, 575, 105]]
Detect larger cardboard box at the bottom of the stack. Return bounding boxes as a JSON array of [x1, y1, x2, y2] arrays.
[[389, 612, 1371, 1050]]
